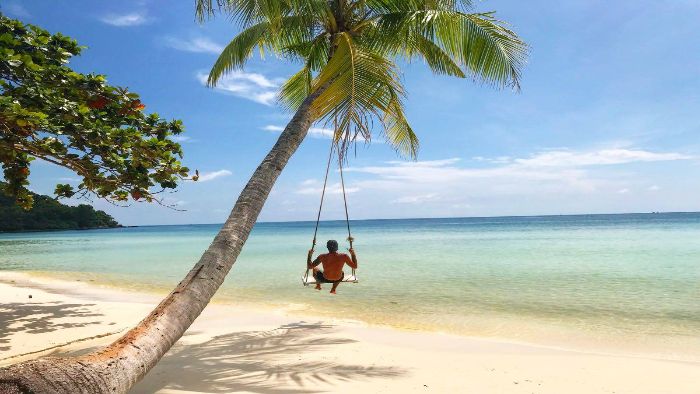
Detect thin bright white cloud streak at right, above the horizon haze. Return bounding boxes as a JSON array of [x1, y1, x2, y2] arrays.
[[514, 149, 693, 167]]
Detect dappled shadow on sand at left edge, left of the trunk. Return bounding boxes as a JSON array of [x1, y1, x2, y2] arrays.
[[0, 302, 103, 352]]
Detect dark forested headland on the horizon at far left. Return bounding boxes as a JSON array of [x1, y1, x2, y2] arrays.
[[0, 183, 120, 232]]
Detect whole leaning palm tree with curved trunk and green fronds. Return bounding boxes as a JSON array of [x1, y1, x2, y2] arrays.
[[0, 0, 527, 393]]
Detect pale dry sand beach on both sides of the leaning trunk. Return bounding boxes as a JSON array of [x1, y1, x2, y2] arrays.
[[0, 271, 700, 394]]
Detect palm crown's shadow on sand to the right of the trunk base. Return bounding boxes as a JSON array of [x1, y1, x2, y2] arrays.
[[131, 322, 406, 394]]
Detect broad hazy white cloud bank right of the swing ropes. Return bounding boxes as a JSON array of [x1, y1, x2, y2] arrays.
[[346, 150, 691, 216]]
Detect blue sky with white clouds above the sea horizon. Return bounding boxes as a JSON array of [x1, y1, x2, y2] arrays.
[[2, 0, 700, 225]]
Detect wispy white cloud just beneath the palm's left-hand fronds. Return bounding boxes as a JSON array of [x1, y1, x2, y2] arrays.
[[197, 70, 282, 105]]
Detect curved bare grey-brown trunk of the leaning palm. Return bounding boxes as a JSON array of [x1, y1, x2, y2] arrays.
[[0, 88, 324, 394]]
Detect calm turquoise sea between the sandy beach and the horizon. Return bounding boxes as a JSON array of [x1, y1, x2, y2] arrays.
[[0, 213, 700, 358]]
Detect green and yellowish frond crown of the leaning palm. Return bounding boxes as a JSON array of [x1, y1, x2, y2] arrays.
[[196, 0, 527, 157]]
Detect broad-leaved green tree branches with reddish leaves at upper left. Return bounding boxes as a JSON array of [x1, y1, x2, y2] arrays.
[[0, 14, 189, 208]]
